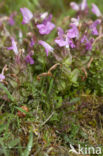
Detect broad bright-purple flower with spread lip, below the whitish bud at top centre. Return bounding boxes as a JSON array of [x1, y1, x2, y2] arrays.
[[37, 15, 55, 35]]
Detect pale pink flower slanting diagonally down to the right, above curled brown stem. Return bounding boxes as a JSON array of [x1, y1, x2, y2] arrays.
[[38, 40, 54, 56]]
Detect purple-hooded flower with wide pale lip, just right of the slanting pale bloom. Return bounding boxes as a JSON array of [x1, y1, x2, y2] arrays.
[[55, 27, 68, 47]]
